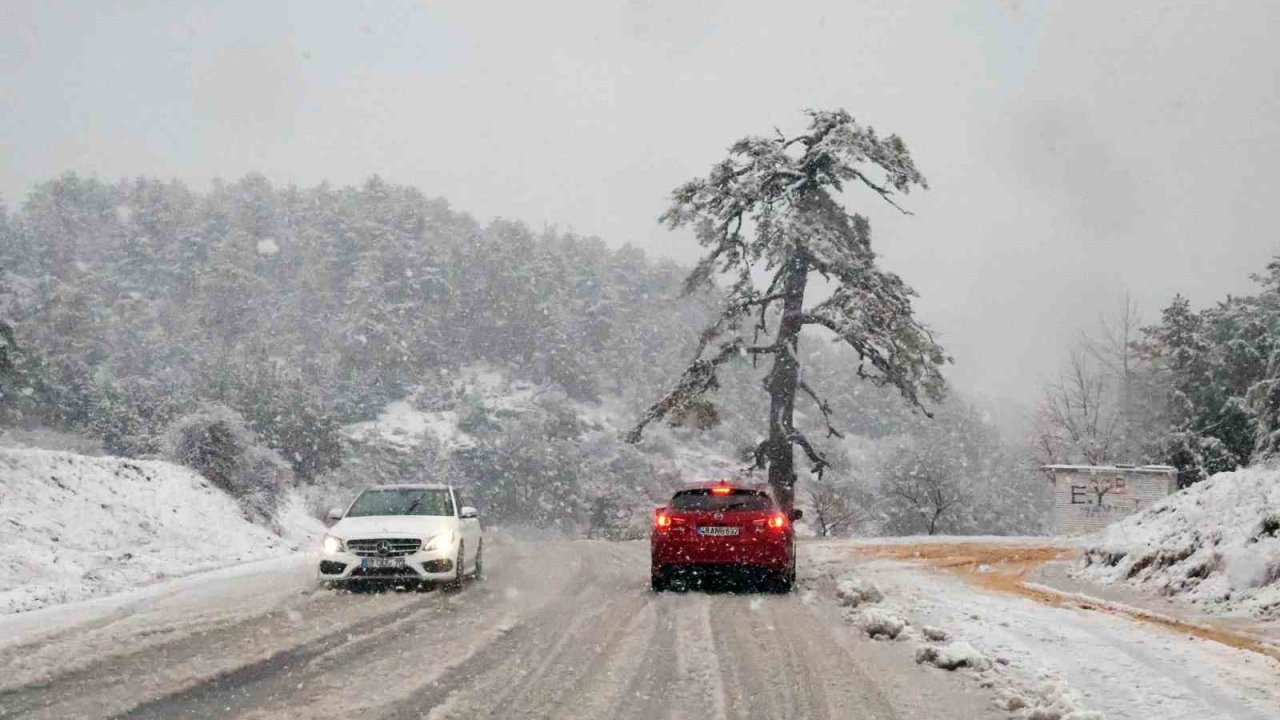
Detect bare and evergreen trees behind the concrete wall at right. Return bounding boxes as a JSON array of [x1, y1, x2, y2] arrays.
[[1033, 258, 1280, 487]]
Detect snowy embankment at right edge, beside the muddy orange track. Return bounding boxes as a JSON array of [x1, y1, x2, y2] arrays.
[[1082, 466, 1280, 620]]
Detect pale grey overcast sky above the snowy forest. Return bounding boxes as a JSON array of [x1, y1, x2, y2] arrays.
[[0, 0, 1280, 409]]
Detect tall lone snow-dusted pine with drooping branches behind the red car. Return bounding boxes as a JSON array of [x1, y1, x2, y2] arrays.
[[627, 110, 948, 510]]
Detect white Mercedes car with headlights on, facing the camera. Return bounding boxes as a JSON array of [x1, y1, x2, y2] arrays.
[[320, 484, 484, 585]]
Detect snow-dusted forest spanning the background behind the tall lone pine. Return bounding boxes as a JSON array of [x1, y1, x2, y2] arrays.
[[0, 174, 1280, 536]]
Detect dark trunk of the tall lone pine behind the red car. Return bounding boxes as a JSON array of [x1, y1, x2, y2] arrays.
[[764, 256, 809, 514]]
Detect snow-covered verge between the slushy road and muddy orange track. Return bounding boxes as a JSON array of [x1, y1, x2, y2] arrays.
[[808, 538, 1280, 720]]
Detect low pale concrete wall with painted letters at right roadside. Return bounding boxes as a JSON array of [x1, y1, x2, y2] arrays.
[[1044, 465, 1178, 536]]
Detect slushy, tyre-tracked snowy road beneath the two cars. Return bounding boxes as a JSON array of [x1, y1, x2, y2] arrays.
[[0, 542, 1007, 720]]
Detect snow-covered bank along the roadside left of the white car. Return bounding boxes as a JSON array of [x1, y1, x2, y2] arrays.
[[0, 448, 319, 614]]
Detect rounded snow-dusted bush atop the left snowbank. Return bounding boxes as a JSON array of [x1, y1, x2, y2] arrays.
[[165, 404, 289, 523]]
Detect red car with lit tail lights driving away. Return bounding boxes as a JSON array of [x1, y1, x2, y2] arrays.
[[650, 480, 801, 592]]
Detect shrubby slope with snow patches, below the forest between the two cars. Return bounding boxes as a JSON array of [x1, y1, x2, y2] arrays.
[[302, 365, 745, 538]]
